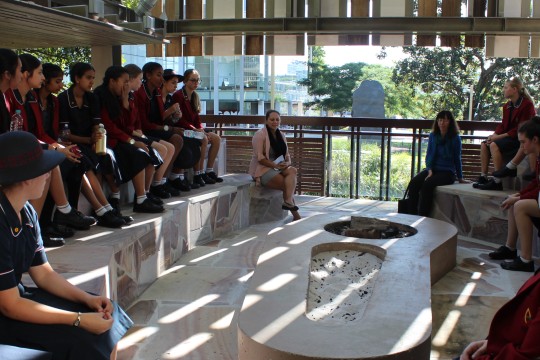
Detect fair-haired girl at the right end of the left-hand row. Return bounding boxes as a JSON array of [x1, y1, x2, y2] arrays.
[[172, 69, 223, 186]]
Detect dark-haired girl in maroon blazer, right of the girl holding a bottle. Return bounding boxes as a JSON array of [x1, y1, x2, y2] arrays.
[[96, 66, 163, 213]]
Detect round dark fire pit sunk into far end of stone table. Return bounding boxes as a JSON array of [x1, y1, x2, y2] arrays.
[[324, 216, 418, 239]]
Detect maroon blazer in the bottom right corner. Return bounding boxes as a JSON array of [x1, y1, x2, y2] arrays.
[[477, 272, 540, 360]]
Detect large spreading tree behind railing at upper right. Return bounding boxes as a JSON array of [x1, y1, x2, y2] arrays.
[[393, 46, 540, 120]]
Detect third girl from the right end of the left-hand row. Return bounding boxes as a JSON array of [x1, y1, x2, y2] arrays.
[[135, 62, 184, 196]]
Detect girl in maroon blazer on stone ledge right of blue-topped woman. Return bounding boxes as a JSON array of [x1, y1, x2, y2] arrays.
[[473, 78, 536, 190]]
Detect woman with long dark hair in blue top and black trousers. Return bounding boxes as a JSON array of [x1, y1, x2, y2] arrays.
[[402, 111, 467, 216]]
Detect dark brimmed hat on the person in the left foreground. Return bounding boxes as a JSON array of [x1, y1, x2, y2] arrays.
[[0, 131, 66, 185]]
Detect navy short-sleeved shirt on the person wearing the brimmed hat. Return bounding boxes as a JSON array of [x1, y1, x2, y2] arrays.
[[0, 191, 47, 291]]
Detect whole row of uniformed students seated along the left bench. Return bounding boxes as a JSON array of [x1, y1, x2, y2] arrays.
[[0, 49, 223, 247]]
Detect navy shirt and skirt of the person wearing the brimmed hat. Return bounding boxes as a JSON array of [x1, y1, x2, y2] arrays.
[[0, 191, 133, 360]]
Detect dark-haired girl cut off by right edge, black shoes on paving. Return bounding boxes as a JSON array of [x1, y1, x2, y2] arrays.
[[489, 116, 540, 272]]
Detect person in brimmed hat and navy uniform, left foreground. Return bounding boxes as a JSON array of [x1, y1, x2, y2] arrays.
[[0, 131, 132, 360]]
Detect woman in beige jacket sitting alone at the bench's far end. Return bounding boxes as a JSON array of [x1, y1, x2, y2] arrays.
[[249, 110, 301, 220]]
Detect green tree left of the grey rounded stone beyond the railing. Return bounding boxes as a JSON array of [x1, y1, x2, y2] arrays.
[[298, 47, 365, 115]]
